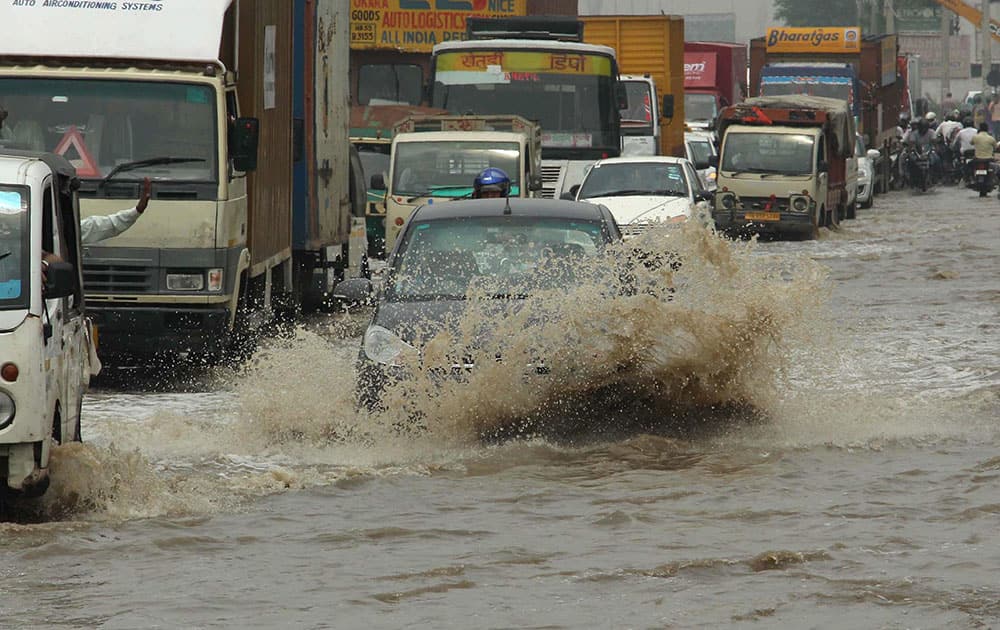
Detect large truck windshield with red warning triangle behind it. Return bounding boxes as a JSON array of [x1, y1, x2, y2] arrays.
[[0, 79, 218, 182]]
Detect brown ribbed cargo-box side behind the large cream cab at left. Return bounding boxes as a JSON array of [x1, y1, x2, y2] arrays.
[[237, 0, 293, 273]]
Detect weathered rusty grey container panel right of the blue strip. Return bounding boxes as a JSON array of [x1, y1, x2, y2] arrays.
[[306, 0, 351, 250]]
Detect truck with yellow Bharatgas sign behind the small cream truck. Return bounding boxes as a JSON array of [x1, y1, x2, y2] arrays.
[[750, 27, 903, 146]]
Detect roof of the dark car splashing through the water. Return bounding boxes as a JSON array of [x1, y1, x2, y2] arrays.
[[413, 197, 603, 221]]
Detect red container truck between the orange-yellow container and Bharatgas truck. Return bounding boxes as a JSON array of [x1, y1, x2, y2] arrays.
[[684, 42, 747, 128]]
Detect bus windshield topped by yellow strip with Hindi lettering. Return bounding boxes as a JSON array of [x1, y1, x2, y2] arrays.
[[433, 48, 621, 159]]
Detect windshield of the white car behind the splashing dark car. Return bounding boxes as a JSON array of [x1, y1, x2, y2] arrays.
[[578, 162, 690, 199]]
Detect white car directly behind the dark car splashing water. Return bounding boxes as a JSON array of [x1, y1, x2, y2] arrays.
[[576, 156, 710, 238]]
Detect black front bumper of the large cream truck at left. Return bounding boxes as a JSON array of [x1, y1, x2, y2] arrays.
[[87, 303, 231, 359]]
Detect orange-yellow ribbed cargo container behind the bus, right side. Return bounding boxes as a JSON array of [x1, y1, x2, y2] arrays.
[[580, 15, 685, 157]]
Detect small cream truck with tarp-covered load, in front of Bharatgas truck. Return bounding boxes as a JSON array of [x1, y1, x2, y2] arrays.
[[713, 97, 857, 238]]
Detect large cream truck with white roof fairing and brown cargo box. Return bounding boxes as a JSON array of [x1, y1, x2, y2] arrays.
[[0, 0, 278, 357]]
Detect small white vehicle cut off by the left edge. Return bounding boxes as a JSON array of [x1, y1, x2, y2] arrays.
[[0, 149, 100, 497]]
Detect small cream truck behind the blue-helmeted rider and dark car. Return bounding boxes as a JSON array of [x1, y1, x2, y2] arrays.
[[378, 116, 542, 252]]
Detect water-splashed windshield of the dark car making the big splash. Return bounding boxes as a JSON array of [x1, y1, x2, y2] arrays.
[[386, 216, 610, 302]]
